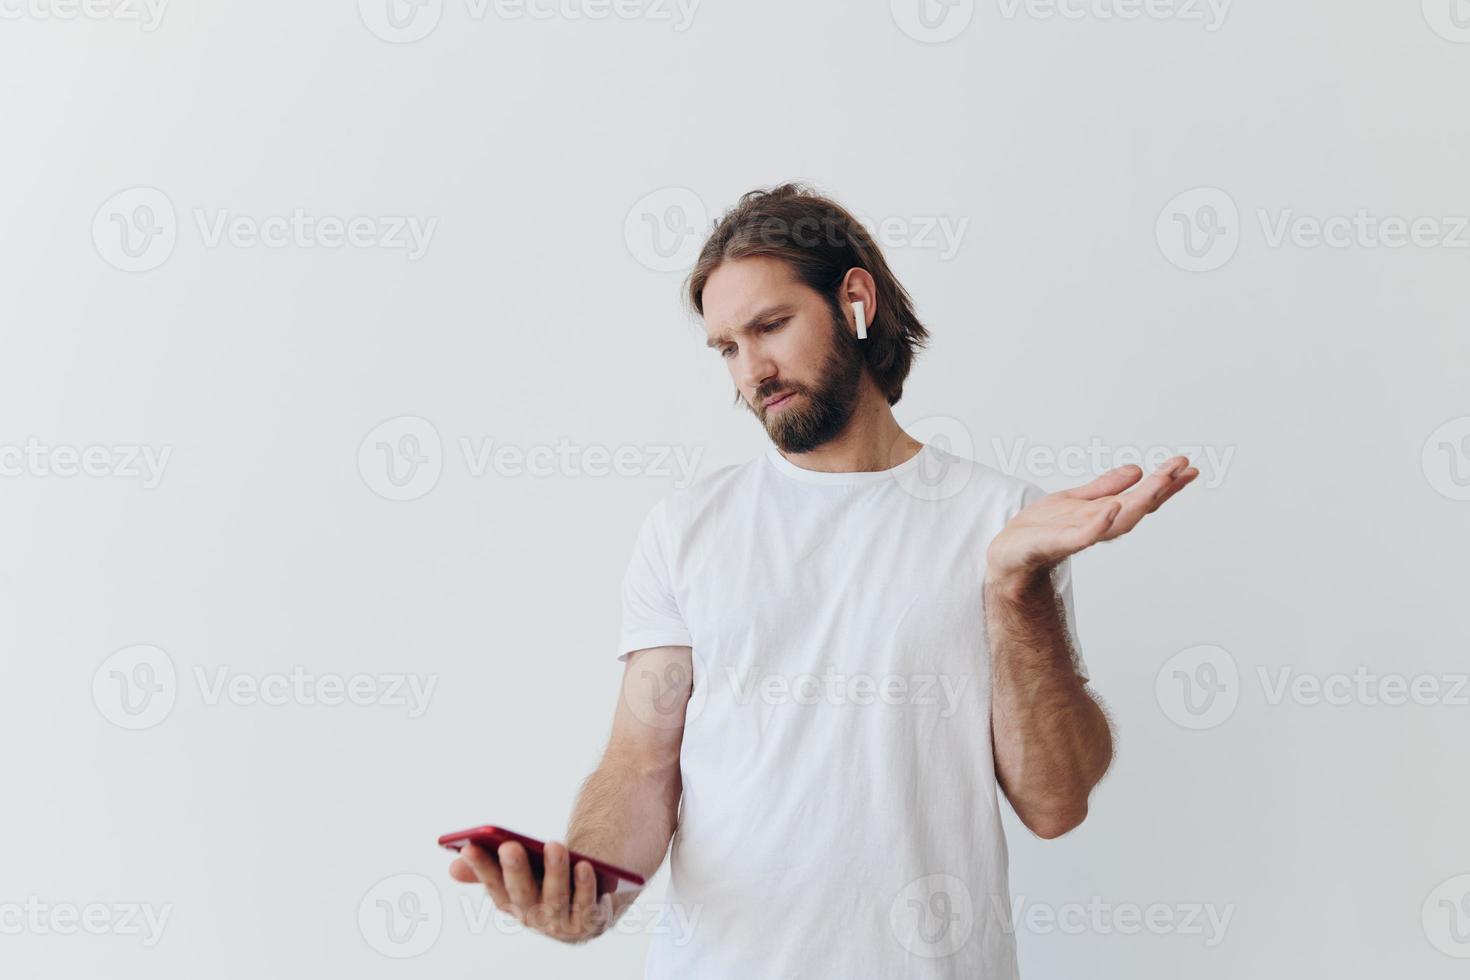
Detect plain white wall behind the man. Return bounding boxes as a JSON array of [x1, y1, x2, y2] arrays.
[[0, 0, 1470, 980]]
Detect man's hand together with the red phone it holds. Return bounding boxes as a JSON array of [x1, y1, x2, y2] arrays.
[[440, 827, 645, 943]]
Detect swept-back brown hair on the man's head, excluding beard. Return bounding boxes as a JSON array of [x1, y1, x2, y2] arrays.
[[686, 184, 929, 404]]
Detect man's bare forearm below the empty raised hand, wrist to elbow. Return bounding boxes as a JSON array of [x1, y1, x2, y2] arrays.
[[985, 574, 1113, 837]]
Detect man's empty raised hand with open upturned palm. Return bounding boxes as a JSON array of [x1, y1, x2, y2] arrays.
[[985, 455, 1200, 583]]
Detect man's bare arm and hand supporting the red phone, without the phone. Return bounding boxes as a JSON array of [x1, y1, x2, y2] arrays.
[[450, 646, 694, 943]]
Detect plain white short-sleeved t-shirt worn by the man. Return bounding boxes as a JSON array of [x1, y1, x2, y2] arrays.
[[619, 445, 1086, 980]]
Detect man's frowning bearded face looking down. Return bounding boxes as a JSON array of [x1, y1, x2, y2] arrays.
[[704, 256, 863, 453]]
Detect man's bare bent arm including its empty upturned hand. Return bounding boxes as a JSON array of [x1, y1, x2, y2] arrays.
[[985, 455, 1200, 837]]
